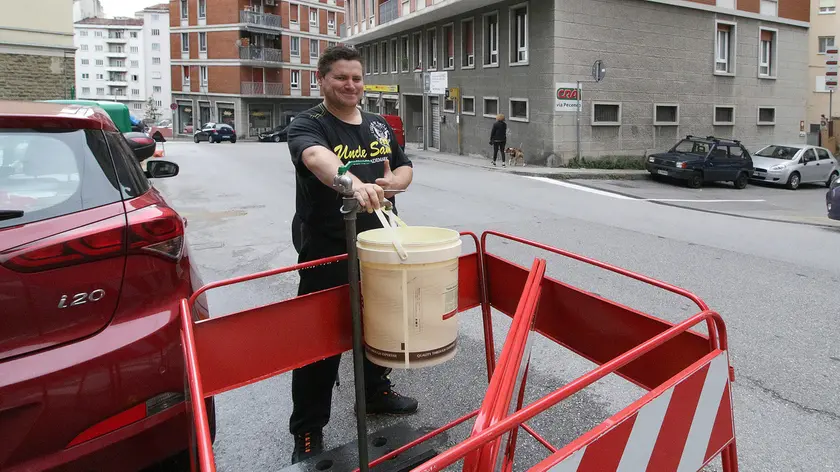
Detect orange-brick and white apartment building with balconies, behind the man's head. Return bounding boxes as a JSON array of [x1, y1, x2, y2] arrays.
[[170, 0, 345, 137]]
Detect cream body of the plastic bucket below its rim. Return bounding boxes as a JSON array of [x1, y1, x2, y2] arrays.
[[361, 259, 458, 368]]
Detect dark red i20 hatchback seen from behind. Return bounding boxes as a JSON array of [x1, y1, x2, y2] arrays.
[[0, 102, 215, 472]]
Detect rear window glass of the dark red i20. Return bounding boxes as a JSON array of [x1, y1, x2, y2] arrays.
[[0, 130, 122, 228]]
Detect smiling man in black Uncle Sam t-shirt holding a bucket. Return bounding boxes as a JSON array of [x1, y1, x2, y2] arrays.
[[289, 42, 417, 464]]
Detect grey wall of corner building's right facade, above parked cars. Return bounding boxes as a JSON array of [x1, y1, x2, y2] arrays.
[[553, 0, 813, 160]]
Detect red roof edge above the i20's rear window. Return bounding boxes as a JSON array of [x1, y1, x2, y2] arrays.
[[0, 100, 118, 131]]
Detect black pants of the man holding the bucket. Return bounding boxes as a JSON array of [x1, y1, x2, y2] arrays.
[[289, 221, 391, 434]]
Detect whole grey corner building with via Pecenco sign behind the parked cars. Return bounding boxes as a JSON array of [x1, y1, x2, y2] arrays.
[[343, 0, 813, 165]]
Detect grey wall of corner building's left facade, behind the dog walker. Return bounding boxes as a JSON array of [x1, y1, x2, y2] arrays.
[[356, 1, 554, 163]]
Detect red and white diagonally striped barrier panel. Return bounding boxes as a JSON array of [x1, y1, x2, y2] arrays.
[[531, 350, 735, 472]]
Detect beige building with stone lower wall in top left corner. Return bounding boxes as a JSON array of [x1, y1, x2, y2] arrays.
[[0, 0, 76, 100]]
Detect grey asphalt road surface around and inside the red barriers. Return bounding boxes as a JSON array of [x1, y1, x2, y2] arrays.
[[155, 142, 840, 471]]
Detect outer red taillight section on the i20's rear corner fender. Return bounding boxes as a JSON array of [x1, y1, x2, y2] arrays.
[[128, 205, 184, 260]]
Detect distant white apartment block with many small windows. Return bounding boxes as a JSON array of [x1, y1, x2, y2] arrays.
[[75, 17, 147, 112]]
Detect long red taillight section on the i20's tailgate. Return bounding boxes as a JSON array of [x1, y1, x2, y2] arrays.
[[0, 215, 125, 272]]
